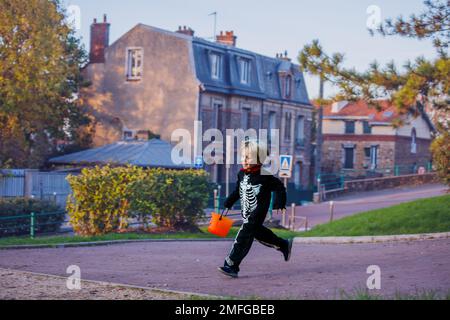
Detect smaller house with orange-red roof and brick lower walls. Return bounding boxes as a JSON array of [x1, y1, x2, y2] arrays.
[[322, 100, 435, 176]]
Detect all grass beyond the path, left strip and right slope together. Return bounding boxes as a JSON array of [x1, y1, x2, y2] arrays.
[[0, 195, 450, 247]]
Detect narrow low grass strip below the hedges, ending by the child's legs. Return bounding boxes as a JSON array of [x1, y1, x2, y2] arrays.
[[0, 227, 300, 247]]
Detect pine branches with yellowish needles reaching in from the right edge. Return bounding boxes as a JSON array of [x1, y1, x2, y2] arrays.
[[298, 0, 450, 184]]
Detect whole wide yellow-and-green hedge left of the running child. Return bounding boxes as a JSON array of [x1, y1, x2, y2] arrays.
[[67, 166, 209, 235]]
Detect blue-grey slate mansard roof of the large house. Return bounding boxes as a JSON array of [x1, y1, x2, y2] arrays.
[[193, 37, 310, 105]]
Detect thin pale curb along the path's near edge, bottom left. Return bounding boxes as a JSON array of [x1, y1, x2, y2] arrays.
[[0, 268, 226, 300]]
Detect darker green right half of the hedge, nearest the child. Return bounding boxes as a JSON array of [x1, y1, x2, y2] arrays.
[[130, 169, 210, 230]]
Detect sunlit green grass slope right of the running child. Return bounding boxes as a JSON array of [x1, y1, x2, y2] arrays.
[[300, 195, 450, 237]]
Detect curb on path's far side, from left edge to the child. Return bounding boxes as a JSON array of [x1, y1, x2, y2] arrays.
[[0, 238, 233, 250]]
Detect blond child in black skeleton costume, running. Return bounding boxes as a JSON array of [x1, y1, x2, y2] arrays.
[[219, 140, 292, 278]]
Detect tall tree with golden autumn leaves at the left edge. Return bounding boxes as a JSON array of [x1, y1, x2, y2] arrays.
[[0, 0, 89, 167]]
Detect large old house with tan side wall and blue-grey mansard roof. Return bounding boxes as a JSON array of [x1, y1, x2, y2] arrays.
[[82, 17, 313, 187]]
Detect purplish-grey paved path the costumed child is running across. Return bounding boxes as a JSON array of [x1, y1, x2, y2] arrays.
[[0, 239, 450, 298]]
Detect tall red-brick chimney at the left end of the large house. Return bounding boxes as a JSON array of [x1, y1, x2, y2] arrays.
[[89, 14, 110, 63]]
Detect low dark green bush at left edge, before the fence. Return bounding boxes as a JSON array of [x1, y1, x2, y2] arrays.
[[0, 198, 65, 237]]
